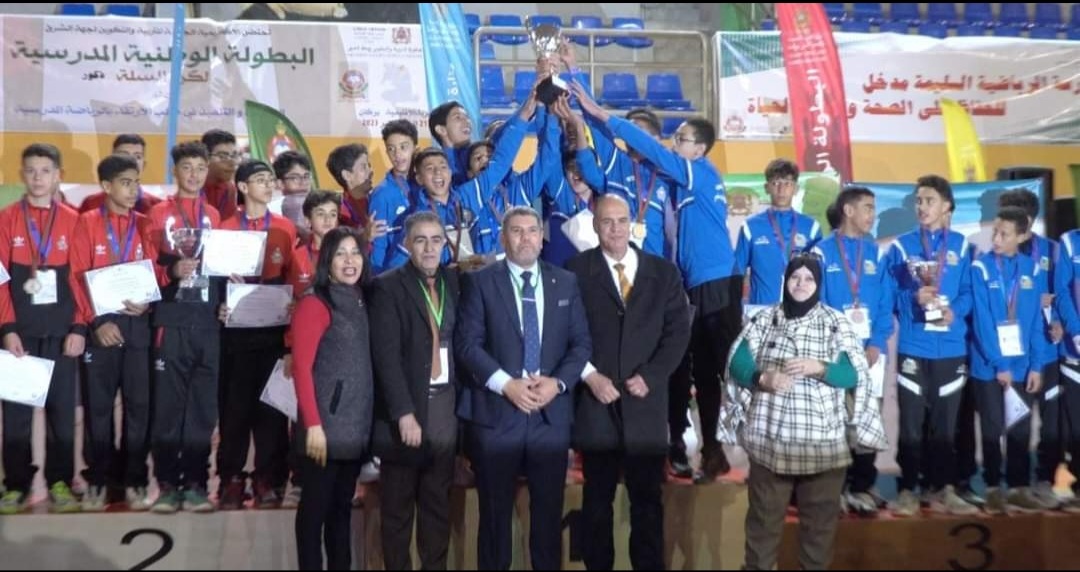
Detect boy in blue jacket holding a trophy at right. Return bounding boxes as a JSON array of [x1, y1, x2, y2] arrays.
[[883, 175, 978, 516]]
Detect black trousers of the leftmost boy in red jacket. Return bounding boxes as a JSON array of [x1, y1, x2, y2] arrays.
[[0, 338, 76, 493]]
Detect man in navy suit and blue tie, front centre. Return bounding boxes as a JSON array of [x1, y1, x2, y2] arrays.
[[455, 207, 592, 570]]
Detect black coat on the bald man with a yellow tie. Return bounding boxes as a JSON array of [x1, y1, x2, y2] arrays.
[[567, 244, 690, 454]]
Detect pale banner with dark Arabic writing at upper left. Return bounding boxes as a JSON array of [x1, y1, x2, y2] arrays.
[[0, 15, 428, 137]]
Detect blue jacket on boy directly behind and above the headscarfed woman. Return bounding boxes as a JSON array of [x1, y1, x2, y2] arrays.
[[735, 208, 821, 305]]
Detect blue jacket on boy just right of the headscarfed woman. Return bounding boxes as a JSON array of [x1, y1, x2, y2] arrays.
[[814, 232, 893, 353]]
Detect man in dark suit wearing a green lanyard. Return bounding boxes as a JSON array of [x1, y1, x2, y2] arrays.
[[370, 212, 459, 570]]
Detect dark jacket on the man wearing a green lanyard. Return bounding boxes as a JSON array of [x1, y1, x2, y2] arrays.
[[368, 262, 460, 465]]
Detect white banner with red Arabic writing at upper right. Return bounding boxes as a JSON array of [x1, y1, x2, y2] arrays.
[[714, 32, 1080, 144]]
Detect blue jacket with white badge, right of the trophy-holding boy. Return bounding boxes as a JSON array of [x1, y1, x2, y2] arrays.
[[971, 253, 1047, 383]]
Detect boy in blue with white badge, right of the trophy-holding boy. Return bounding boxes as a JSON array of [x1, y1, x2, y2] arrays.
[[971, 206, 1048, 514]]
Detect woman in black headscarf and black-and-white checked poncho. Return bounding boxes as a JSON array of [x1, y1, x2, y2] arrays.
[[718, 254, 886, 570]]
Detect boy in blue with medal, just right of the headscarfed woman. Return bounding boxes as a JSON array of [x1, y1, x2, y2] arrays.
[[813, 187, 893, 515]]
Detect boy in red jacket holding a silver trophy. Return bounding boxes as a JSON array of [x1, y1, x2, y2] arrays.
[[144, 141, 225, 514]]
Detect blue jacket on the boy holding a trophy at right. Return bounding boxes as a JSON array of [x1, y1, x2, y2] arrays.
[[885, 229, 972, 359]]
